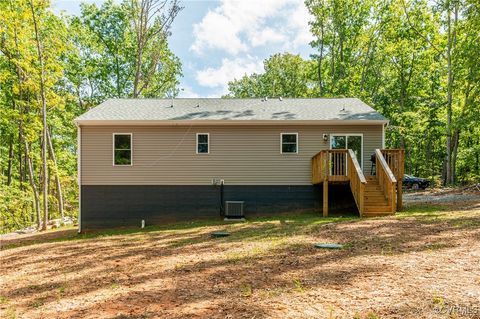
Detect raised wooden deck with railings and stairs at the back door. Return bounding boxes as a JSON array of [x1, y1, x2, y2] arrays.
[[312, 149, 404, 216]]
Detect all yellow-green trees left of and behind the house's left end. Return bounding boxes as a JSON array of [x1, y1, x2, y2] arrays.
[[0, 0, 181, 232]]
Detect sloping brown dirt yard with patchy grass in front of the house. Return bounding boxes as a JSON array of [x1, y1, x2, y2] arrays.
[[0, 194, 480, 319]]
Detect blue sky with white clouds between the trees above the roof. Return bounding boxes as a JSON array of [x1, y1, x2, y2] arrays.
[[53, 0, 312, 97]]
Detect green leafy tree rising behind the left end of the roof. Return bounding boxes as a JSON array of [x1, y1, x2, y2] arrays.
[[68, 0, 181, 105]]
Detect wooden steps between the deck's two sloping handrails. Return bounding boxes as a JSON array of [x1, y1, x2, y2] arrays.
[[362, 176, 395, 217]]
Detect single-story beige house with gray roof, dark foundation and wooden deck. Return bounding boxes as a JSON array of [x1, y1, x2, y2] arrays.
[[75, 98, 403, 230]]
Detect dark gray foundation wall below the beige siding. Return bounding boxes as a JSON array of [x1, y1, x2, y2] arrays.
[[81, 185, 356, 230]]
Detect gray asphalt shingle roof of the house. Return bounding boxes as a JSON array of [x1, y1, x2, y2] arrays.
[[75, 98, 387, 123]]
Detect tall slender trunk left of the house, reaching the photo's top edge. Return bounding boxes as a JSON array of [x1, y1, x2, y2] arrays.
[[30, 0, 48, 230]]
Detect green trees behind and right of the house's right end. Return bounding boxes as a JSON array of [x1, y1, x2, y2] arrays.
[[228, 0, 480, 184]]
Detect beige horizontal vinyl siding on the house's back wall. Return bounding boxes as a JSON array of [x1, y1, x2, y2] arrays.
[[81, 125, 382, 185]]
